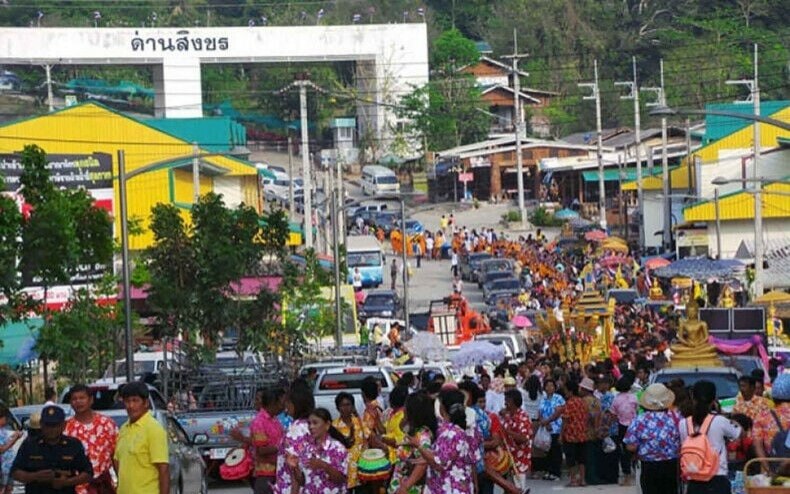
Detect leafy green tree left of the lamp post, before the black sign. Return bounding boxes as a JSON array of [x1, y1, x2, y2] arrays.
[[18, 146, 117, 380]]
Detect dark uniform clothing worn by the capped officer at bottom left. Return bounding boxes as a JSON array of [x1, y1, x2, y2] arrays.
[[11, 407, 93, 494]]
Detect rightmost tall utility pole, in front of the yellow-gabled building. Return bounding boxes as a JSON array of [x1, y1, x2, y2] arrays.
[[727, 43, 764, 298]]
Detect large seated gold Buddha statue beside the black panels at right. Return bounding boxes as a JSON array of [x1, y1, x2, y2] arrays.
[[670, 300, 722, 367]]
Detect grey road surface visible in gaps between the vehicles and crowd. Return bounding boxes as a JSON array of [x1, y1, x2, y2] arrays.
[[209, 184, 639, 494]]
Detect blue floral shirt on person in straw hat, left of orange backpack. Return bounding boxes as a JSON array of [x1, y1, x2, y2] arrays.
[[623, 411, 680, 461]]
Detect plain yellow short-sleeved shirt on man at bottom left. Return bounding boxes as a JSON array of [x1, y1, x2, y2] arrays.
[[114, 412, 170, 494]]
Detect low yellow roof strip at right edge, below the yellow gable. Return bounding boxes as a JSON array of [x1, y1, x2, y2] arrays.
[[683, 183, 790, 221]]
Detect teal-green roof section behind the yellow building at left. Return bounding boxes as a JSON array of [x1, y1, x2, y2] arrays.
[[145, 117, 247, 152]]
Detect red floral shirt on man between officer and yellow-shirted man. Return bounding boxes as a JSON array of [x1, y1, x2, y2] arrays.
[[63, 412, 118, 494]]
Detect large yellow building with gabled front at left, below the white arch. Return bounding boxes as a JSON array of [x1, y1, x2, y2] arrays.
[[0, 103, 259, 250]]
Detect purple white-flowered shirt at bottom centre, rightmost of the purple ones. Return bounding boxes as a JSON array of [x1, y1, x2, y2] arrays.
[[427, 421, 480, 494]]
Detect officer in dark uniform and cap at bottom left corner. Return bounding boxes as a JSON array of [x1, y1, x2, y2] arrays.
[[11, 405, 93, 494]]
